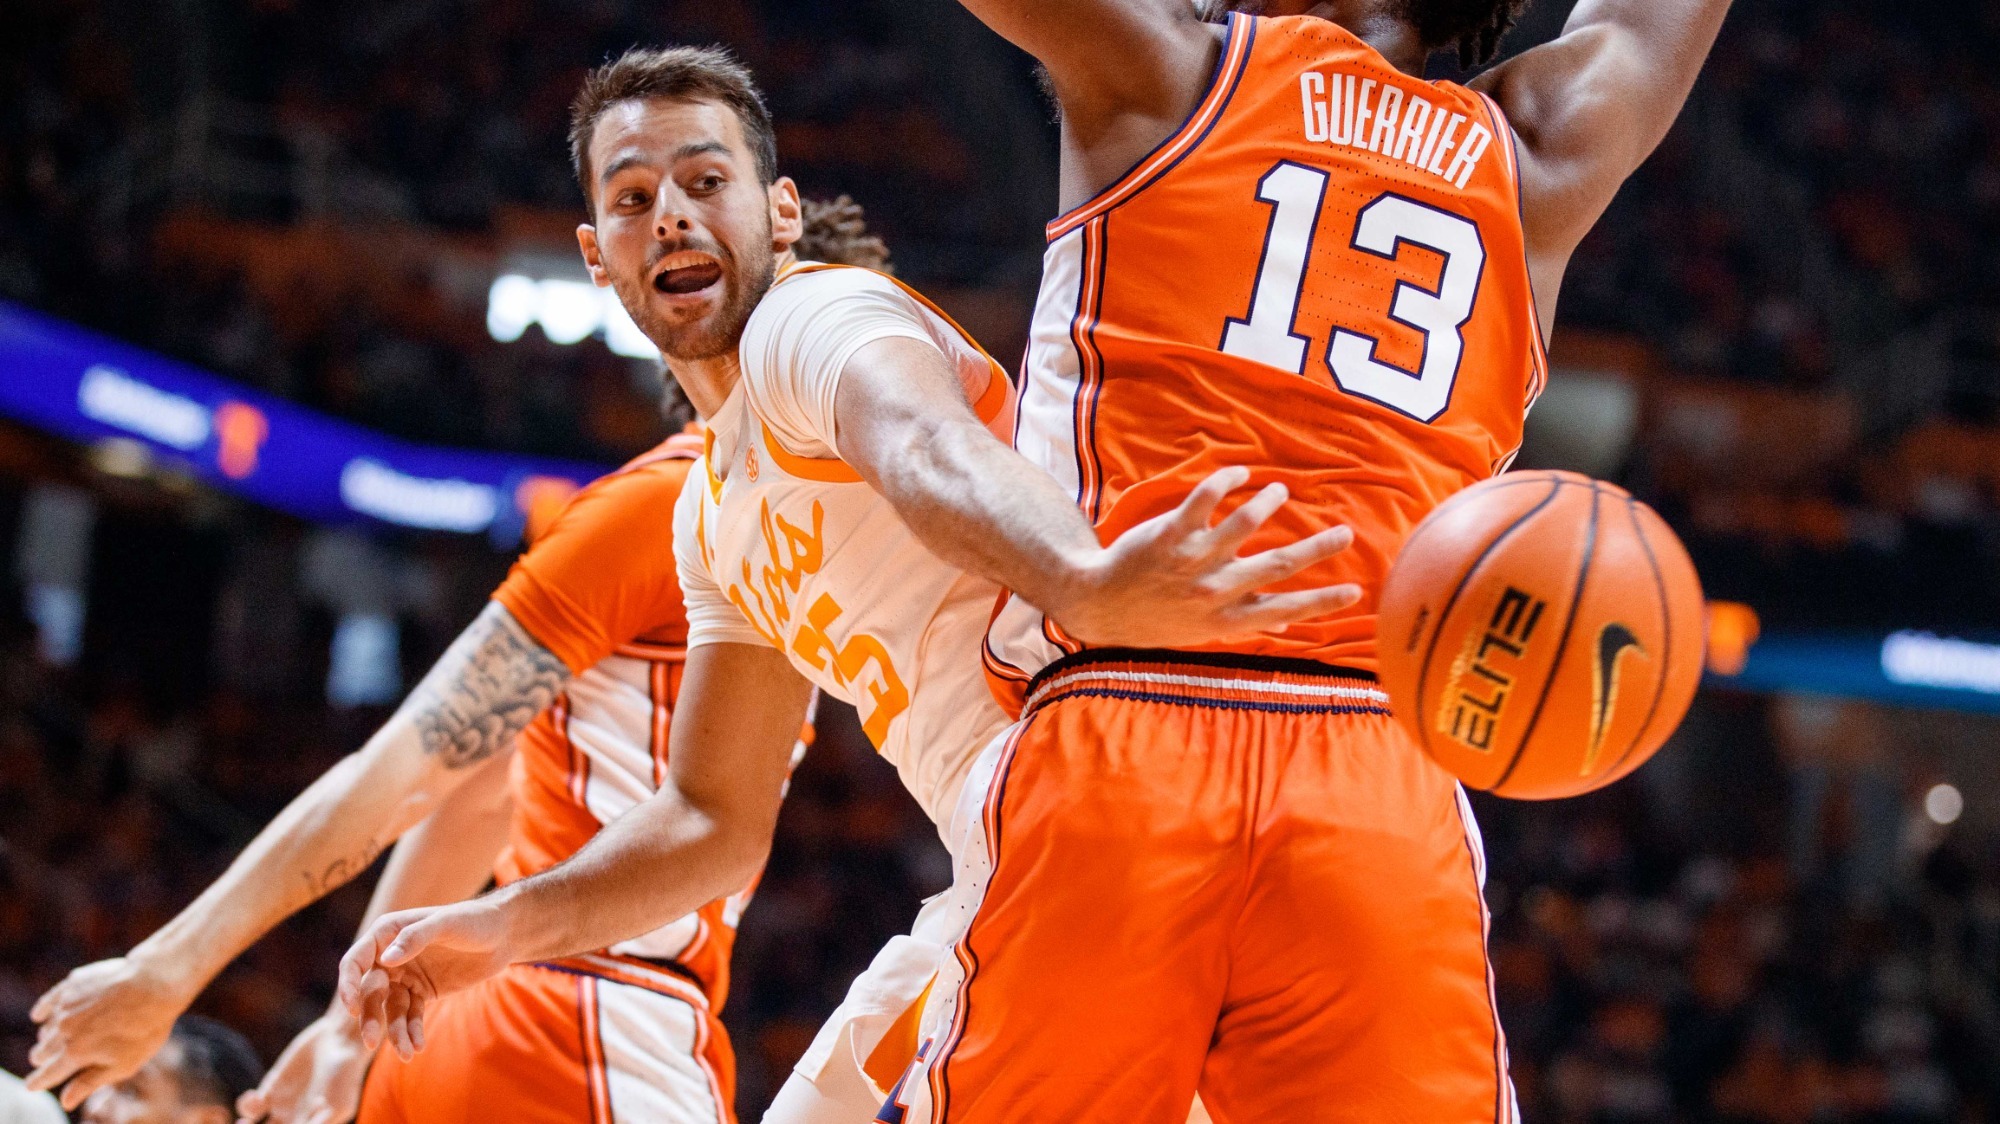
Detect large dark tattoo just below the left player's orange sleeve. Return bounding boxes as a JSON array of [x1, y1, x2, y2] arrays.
[[410, 604, 570, 768]]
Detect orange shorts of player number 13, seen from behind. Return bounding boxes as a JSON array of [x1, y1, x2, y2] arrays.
[[880, 652, 1516, 1124]]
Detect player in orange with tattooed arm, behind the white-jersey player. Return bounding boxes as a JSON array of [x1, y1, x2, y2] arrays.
[[21, 200, 886, 1124]]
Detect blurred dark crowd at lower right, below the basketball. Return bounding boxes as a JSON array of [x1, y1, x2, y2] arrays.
[[1480, 696, 2000, 1124]]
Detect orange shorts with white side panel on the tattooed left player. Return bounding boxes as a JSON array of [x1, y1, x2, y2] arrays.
[[358, 956, 736, 1124]]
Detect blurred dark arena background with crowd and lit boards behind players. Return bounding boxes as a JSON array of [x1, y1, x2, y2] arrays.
[[0, 0, 2000, 1124]]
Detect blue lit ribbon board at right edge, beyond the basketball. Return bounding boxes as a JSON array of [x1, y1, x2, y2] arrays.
[[1708, 630, 2000, 714]]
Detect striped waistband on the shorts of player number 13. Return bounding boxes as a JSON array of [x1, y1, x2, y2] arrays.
[[1022, 648, 1388, 718]]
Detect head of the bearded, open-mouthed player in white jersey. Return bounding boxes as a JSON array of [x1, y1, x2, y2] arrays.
[[576, 98, 798, 360]]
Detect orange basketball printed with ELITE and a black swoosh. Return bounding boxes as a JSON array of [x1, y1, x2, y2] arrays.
[[1380, 472, 1706, 800]]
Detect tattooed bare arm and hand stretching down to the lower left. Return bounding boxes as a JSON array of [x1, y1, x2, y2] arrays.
[[28, 604, 570, 1108]]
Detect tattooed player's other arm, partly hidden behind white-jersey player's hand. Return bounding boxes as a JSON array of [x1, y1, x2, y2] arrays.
[[236, 754, 514, 1124]]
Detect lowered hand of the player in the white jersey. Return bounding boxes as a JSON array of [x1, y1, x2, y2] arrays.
[[338, 898, 514, 1060]]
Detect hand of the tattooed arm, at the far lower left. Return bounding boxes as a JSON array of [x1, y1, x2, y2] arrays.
[[28, 956, 194, 1110]]
